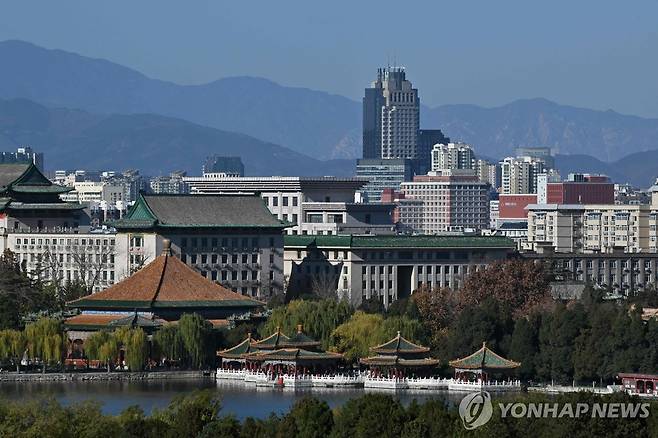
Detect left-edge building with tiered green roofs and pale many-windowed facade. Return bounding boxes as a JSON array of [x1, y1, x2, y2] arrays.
[[0, 162, 119, 290]]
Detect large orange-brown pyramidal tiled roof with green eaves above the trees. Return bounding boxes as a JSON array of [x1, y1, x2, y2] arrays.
[[64, 239, 264, 341]]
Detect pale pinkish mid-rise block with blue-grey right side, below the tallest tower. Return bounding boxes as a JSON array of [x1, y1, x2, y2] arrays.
[[398, 175, 489, 234]]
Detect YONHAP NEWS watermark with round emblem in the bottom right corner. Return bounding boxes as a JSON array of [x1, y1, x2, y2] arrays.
[[459, 391, 651, 430]]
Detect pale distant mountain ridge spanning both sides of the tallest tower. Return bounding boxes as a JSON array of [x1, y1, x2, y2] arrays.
[[0, 41, 658, 161]]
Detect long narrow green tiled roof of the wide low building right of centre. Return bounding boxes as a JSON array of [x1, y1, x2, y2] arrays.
[[284, 235, 516, 249]]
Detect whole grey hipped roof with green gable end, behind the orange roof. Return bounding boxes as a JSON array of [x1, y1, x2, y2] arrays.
[[112, 194, 286, 230]]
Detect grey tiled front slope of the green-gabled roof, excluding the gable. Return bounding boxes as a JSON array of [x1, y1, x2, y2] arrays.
[[143, 195, 283, 227]]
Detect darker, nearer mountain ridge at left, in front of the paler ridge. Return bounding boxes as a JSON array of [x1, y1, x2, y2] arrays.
[[0, 99, 354, 176]]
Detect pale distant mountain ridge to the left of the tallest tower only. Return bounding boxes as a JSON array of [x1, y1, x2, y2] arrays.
[[0, 41, 361, 158]]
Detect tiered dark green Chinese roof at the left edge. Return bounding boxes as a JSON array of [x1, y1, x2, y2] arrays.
[[0, 163, 79, 210]]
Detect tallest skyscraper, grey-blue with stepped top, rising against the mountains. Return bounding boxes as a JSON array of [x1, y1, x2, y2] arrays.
[[363, 67, 420, 159]]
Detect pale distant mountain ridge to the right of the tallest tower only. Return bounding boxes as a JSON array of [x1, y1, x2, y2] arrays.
[[422, 99, 658, 161]]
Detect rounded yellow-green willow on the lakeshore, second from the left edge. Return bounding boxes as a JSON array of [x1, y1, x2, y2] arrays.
[[25, 318, 64, 373]]
